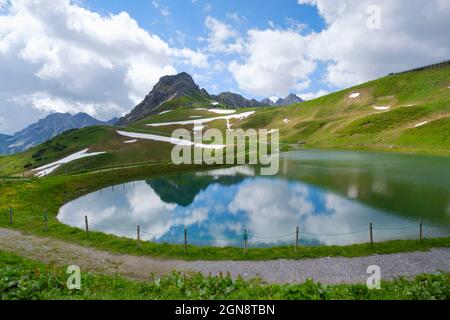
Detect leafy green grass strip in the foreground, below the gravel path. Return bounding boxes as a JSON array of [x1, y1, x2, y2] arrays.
[[0, 251, 450, 300]]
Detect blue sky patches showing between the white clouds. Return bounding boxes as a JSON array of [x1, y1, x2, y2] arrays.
[[81, 0, 326, 99]]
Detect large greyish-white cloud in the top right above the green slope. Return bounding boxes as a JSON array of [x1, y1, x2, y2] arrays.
[[298, 0, 450, 87]]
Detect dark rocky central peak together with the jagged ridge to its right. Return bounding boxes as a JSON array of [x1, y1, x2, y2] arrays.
[[118, 72, 303, 125]]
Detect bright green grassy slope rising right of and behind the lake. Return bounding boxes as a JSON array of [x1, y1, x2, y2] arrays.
[[242, 68, 450, 155]]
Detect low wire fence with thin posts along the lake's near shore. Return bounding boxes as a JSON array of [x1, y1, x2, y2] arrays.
[[3, 207, 450, 253]]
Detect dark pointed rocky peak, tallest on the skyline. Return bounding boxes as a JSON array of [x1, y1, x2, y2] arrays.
[[118, 72, 210, 125]]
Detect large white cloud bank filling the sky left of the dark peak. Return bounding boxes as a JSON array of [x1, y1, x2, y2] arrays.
[[0, 0, 207, 129]]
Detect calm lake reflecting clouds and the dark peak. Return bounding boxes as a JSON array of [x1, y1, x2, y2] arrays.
[[58, 150, 450, 247]]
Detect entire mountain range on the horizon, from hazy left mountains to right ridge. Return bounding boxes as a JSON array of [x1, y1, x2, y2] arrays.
[[0, 72, 303, 154]]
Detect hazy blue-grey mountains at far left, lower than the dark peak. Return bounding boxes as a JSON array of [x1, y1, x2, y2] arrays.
[[0, 113, 117, 154]]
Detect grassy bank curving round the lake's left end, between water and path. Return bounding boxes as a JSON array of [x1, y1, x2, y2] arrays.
[[0, 164, 450, 260]]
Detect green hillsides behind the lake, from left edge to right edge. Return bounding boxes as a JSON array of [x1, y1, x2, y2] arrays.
[[0, 68, 450, 176]]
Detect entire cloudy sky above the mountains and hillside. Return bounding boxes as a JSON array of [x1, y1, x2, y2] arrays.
[[0, 0, 450, 134]]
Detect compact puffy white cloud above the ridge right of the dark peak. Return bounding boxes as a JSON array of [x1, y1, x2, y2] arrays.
[[229, 29, 316, 96]]
